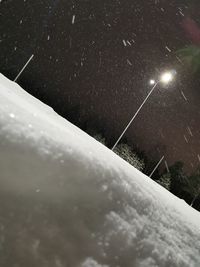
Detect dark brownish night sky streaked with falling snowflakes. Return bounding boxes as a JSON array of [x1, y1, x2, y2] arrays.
[[0, 0, 200, 174]]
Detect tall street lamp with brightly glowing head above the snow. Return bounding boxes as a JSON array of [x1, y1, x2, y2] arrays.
[[112, 70, 176, 151]]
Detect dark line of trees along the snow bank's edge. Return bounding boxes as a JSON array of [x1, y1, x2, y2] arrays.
[[62, 105, 200, 211]]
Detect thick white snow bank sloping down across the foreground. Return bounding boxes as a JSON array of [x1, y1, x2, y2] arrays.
[[0, 75, 200, 267]]
